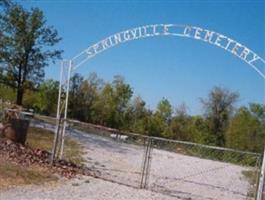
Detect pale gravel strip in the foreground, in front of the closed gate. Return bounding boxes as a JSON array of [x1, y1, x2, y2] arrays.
[[0, 177, 176, 200]]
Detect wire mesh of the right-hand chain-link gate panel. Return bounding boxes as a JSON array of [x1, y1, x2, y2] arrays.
[[148, 138, 261, 200]]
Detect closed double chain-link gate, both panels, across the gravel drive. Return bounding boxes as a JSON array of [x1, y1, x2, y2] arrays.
[[32, 115, 261, 200]]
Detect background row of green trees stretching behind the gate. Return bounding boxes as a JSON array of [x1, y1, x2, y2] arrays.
[[0, 73, 265, 152]]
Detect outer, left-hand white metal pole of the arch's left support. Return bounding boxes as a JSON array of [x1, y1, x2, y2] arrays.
[[50, 61, 64, 164]]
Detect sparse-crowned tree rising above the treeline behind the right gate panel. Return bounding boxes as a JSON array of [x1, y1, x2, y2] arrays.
[[201, 87, 239, 146]]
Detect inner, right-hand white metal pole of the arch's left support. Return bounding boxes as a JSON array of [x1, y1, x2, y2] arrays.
[[60, 60, 72, 159]]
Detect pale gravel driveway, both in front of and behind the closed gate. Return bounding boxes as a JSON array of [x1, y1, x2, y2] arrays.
[[0, 120, 255, 200]]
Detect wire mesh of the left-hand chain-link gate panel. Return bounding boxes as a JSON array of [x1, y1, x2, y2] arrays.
[[68, 123, 147, 188]]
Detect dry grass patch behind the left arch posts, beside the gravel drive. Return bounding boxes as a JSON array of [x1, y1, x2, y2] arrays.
[[26, 127, 84, 164]]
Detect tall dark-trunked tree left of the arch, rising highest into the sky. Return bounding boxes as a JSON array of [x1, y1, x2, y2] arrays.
[[0, 5, 62, 105]]
